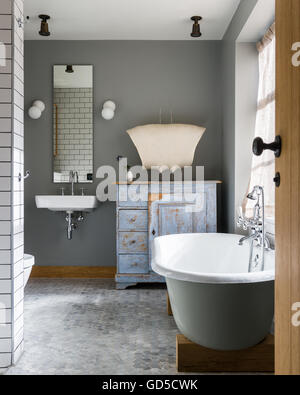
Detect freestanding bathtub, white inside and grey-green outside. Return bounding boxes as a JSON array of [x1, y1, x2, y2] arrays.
[[152, 233, 275, 350]]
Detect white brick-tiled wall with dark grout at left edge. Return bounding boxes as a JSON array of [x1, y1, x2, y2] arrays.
[[0, 0, 24, 371]]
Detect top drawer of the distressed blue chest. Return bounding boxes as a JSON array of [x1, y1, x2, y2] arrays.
[[118, 185, 148, 207]]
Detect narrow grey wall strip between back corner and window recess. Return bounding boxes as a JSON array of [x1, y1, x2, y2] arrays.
[[221, 0, 258, 232]]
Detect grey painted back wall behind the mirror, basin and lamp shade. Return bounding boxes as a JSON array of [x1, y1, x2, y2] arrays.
[[25, 41, 223, 266]]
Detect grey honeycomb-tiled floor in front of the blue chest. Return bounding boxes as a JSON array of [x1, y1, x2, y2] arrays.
[[6, 279, 178, 375]]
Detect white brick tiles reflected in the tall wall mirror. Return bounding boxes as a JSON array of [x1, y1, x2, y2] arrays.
[[53, 88, 93, 182]]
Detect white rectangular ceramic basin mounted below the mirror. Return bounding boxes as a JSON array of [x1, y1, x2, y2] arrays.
[[35, 195, 98, 212]]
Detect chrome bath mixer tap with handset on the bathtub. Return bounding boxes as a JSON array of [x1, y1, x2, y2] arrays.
[[237, 186, 270, 271]]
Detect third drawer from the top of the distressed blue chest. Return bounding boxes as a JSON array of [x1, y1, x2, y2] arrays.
[[119, 232, 148, 254]]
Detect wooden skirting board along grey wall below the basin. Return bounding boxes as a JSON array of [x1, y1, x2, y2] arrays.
[[31, 266, 116, 278]]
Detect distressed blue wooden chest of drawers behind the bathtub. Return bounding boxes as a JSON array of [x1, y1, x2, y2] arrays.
[[115, 181, 219, 289]]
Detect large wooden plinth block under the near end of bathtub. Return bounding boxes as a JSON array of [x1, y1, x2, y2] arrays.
[[176, 335, 274, 373]]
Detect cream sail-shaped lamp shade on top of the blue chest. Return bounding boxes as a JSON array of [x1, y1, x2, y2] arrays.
[[127, 124, 206, 169]]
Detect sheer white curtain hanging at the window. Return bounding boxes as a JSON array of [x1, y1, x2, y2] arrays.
[[243, 24, 276, 218]]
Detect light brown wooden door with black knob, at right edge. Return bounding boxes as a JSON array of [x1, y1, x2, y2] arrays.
[[275, 0, 300, 374]]
